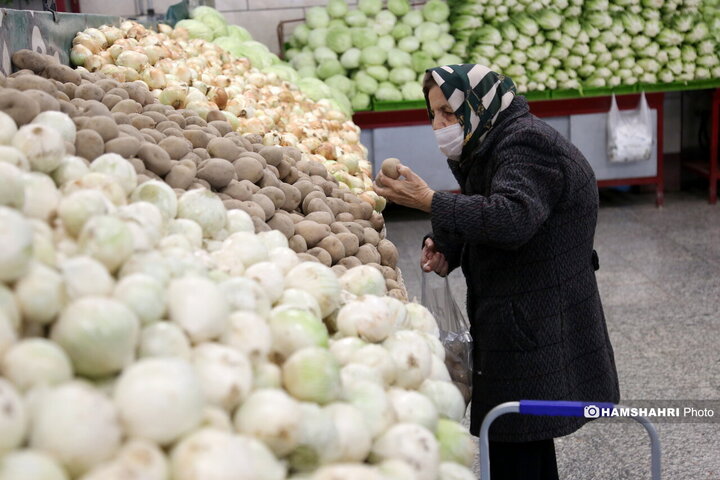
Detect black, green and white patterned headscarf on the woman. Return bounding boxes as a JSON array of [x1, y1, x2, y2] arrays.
[[425, 63, 515, 157]]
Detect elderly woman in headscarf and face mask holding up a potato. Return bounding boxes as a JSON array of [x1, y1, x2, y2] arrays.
[[375, 64, 620, 480]]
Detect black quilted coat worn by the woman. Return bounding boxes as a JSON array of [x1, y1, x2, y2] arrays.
[[431, 97, 620, 442]]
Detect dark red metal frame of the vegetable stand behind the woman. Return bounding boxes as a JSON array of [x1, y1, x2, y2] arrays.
[[353, 91, 665, 206]]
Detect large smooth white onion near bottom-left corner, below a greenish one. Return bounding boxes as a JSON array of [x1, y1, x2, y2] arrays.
[[30, 382, 122, 478]]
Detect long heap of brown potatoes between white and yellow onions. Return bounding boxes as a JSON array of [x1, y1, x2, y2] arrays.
[[0, 50, 407, 300]]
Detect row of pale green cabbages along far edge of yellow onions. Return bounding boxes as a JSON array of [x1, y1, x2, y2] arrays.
[[175, 7, 352, 116]]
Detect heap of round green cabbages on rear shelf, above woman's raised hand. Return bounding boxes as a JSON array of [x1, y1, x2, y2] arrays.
[[285, 0, 462, 110]]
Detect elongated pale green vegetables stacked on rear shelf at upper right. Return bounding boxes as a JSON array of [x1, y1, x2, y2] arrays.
[[449, 0, 720, 92]]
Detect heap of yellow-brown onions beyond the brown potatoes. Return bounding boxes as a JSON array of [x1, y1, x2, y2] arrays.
[[71, 17, 385, 211]]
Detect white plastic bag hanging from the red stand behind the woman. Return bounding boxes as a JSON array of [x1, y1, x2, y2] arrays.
[[607, 93, 654, 163]]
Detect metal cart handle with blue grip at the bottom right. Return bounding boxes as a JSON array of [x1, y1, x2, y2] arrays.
[[480, 400, 661, 480]]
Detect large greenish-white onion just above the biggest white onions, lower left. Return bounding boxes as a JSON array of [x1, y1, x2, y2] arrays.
[[51, 297, 140, 378]]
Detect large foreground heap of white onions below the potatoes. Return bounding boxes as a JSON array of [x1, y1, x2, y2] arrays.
[[0, 112, 474, 480]]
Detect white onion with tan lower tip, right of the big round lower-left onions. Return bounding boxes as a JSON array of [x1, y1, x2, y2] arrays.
[[192, 342, 253, 412]]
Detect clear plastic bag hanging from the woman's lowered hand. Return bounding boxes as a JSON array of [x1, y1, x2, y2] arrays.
[[421, 273, 473, 403]]
